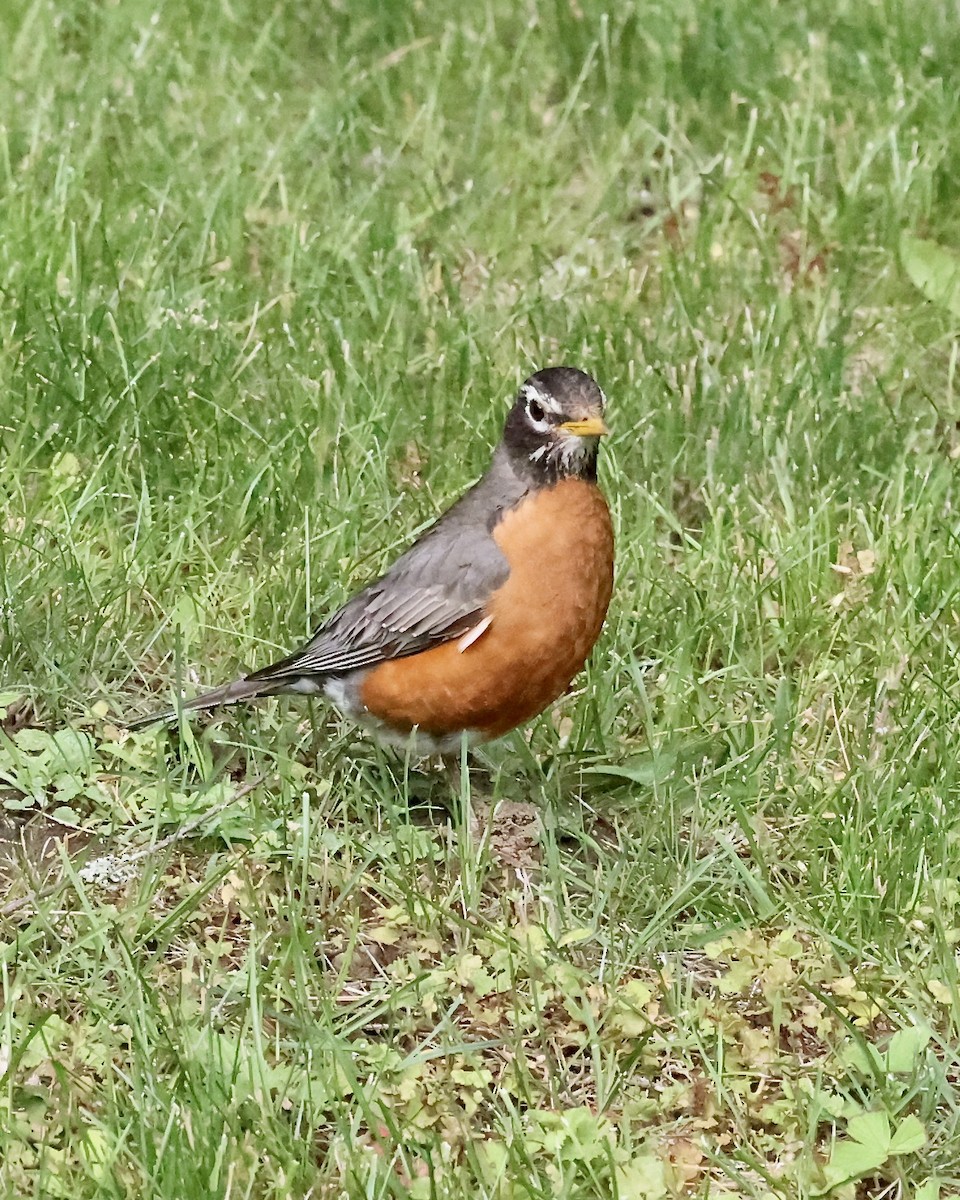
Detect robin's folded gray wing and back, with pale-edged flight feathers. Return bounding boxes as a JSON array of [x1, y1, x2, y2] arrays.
[[247, 463, 517, 683]]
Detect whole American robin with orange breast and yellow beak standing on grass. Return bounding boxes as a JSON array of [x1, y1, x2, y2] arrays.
[[131, 367, 613, 752]]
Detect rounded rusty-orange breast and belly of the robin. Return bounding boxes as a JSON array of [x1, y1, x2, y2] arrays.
[[361, 479, 613, 738]]
